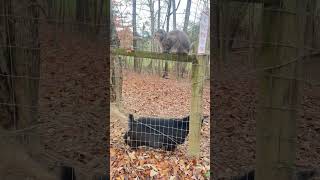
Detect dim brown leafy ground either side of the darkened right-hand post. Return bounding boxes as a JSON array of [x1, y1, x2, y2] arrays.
[[212, 54, 320, 177]]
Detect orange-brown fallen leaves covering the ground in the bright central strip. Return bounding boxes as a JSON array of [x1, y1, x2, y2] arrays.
[[110, 71, 210, 180]]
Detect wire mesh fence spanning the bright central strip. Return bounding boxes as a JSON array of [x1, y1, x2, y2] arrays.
[[110, 0, 210, 179]]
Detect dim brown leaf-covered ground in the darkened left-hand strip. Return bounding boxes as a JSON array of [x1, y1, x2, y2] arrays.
[[39, 26, 107, 177]]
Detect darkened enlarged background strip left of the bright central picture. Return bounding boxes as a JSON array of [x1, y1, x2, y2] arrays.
[[0, 0, 107, 180]]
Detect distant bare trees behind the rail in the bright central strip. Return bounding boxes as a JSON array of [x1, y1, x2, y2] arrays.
[[111, 0, 209, 78]]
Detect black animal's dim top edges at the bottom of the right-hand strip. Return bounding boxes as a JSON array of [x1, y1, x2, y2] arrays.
[[219, 169, 320, 180]]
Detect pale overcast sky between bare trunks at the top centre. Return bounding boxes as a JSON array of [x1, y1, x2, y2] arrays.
[[115, 0, 209, 34]]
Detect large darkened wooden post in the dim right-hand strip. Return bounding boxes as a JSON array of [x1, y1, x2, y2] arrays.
[[255, 0, 304, 180]]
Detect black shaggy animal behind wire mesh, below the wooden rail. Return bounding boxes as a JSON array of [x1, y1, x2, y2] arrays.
[[123, 114, 208, 151]]
